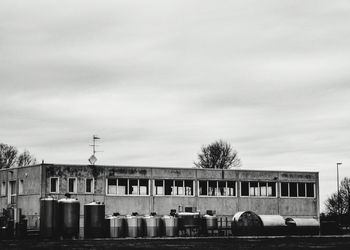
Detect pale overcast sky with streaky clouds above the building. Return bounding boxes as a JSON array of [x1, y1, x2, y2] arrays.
[[0, 0, 350, 211]]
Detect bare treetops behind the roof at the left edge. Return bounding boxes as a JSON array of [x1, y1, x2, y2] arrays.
[[0, 143, 36, 169]]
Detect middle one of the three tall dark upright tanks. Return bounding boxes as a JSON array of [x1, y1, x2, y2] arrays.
[[58, 198, 80, 238]]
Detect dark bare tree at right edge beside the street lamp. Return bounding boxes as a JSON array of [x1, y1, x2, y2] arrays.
[[325, 177, 350, 215]]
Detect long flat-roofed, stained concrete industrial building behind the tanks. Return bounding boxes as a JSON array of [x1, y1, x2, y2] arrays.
[[0, 164, 319, 229]]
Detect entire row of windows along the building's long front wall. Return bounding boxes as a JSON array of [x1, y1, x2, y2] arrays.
[[45, 177, 316, 197]]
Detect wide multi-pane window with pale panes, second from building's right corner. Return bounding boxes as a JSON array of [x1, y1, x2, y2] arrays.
[[241, 181, 276, 197]]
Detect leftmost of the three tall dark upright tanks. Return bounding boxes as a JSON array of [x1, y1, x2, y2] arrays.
[[40, 197, 58, 238]]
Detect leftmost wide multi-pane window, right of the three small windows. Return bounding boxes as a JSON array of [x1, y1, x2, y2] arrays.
[[107, 178, 149, 195]]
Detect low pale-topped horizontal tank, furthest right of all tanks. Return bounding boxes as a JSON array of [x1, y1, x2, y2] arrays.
[[286, 217, 320, 235]]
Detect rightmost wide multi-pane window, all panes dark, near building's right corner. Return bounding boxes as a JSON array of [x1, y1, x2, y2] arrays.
[[281, 182, 315, 198]]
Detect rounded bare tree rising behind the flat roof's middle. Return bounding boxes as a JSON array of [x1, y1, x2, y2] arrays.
[[194, 140, 241, 169]]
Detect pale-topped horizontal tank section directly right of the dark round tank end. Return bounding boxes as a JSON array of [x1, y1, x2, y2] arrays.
[[259, 215, 287, 235]]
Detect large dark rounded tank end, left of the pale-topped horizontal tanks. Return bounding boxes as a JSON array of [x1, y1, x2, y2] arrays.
[[231, 211, 263, 235]]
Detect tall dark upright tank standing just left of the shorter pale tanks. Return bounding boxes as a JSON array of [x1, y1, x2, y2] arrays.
[[84, 201, 105, 238]]
